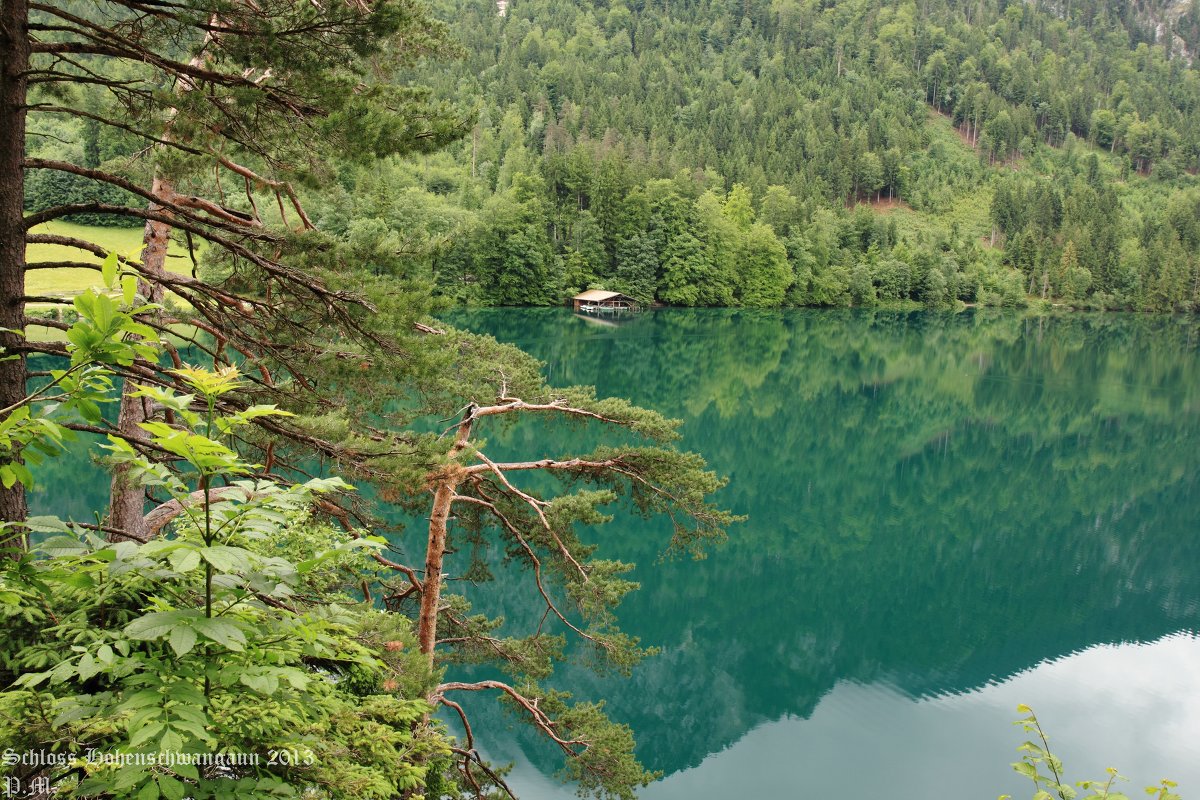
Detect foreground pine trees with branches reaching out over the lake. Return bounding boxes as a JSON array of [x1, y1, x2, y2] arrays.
[[0, 0, 730, 796]]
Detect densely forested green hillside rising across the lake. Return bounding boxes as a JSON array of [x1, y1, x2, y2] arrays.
[[25, 0, 1200, 311]]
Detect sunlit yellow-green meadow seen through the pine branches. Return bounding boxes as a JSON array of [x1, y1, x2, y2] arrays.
[[25, 221, 192, 297]]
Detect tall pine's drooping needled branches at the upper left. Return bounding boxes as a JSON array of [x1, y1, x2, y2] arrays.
[[4, 2, 465, 539]]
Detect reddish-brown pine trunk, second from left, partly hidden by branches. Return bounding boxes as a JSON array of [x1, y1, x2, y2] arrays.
[[108, 178, 175, 541]]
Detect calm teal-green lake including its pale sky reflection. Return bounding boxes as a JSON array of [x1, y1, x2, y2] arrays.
[[436, 308, 1200, 800]]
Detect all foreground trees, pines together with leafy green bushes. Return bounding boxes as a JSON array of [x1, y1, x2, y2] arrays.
[[0, 0, 732, 796]]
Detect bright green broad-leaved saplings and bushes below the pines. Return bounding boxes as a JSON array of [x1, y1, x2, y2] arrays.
[[0, 297, 452, 800]]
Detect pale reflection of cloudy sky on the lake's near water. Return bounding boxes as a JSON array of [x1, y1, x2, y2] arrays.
[[491, 636, 1200, 800]]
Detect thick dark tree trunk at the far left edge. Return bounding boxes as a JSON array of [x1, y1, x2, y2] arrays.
[[0, 0, 30, 544]]
